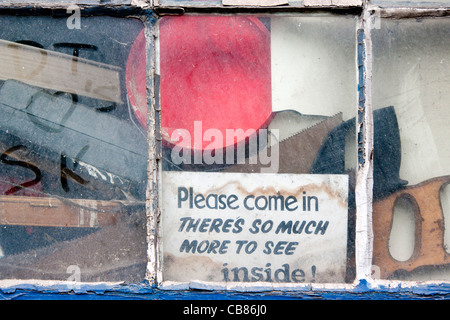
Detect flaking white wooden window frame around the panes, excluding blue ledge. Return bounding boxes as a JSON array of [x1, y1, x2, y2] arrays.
[[0, 0, 450, 298]]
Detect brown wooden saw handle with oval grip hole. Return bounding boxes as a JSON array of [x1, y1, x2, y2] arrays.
[[373, 176, 450, 279]]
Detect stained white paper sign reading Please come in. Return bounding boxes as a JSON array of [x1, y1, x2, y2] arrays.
[[161, 172, 348, 283]]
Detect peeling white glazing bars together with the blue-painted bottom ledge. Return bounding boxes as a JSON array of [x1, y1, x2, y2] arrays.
[[0, 0, 450, 299]]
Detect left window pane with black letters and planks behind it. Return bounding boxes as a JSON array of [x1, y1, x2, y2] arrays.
[[0, 16, 147, 282]]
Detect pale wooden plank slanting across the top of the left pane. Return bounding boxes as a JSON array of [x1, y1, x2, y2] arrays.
[[0, 39, 122, 103]]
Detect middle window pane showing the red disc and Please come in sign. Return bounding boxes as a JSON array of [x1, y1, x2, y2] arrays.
[[157, 15, 357, 283]]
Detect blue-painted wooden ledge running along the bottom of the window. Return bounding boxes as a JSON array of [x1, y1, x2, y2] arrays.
[[0, 281, 450, 301]]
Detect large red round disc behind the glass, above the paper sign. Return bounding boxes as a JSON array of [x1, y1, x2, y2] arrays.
[[127, 16, 272, 150]]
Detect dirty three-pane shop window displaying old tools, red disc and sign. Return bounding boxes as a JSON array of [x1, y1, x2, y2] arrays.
[[0, 0, 450, 294]]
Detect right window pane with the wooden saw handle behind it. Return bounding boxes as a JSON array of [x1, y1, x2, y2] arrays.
[[373, 18, 450, 280]]
